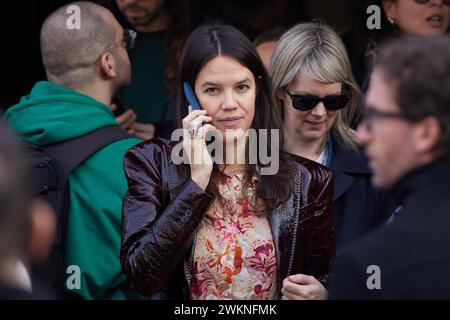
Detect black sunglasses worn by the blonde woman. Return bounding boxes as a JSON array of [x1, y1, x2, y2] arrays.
[[286, 86, 352, 111]]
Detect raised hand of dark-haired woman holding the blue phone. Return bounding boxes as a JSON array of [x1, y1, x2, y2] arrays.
[[182, 106, 216, 190]]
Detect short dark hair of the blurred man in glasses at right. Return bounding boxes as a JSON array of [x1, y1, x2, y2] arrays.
[[375, 36, 450, 151]]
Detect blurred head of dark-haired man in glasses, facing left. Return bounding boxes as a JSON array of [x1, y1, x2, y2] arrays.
[[358, 37, 450, 188]]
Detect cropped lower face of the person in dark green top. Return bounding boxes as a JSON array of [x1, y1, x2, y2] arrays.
[[116, 0, 169, 32]]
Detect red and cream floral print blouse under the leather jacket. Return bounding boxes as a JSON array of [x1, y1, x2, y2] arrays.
[[188, 173, 277, 300]]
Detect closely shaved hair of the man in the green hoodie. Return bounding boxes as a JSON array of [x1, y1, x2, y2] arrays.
[[41, 1, 116, 89]]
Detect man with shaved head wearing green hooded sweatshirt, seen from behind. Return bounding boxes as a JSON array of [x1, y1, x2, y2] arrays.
[[6, 1, 140, 299]]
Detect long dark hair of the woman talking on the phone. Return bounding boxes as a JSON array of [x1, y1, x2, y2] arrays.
[[177, 23, 293, 213]]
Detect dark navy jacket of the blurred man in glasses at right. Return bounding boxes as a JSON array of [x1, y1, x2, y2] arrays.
[[330, 155, 450, 300]]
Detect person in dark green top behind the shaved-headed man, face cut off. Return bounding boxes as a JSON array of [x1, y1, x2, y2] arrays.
[[112, 0, 192, 140]]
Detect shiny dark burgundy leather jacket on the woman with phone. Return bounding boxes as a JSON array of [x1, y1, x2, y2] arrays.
[[120, 139, 335, 299]]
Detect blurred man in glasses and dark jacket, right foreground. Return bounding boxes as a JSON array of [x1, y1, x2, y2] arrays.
[[330, 36, 450, 300]]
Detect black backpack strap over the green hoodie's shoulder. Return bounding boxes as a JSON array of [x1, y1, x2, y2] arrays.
[[43, 126, 132, 173]]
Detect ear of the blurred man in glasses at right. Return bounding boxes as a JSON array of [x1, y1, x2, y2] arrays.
[[414, 116, 442, 153]]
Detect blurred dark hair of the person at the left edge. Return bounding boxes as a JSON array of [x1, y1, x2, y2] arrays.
[[0, 119, 30, 264]]
